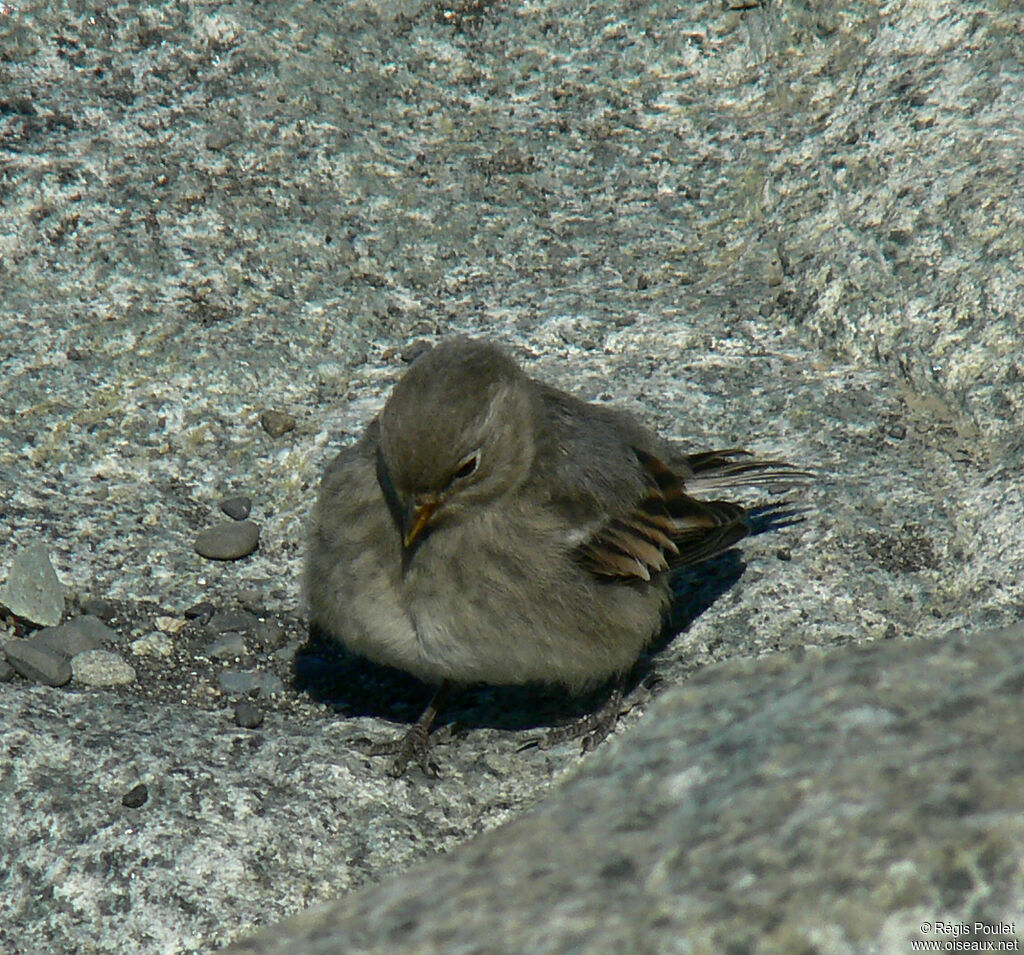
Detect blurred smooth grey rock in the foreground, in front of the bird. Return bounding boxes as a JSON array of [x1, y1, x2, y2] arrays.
[[229, 626, 1024, 955]]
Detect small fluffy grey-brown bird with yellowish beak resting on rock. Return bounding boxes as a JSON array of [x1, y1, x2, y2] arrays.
[[306, 338, 806, 775]]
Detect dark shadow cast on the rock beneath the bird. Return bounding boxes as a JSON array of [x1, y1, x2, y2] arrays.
[[294, 540, 753, 731]]
